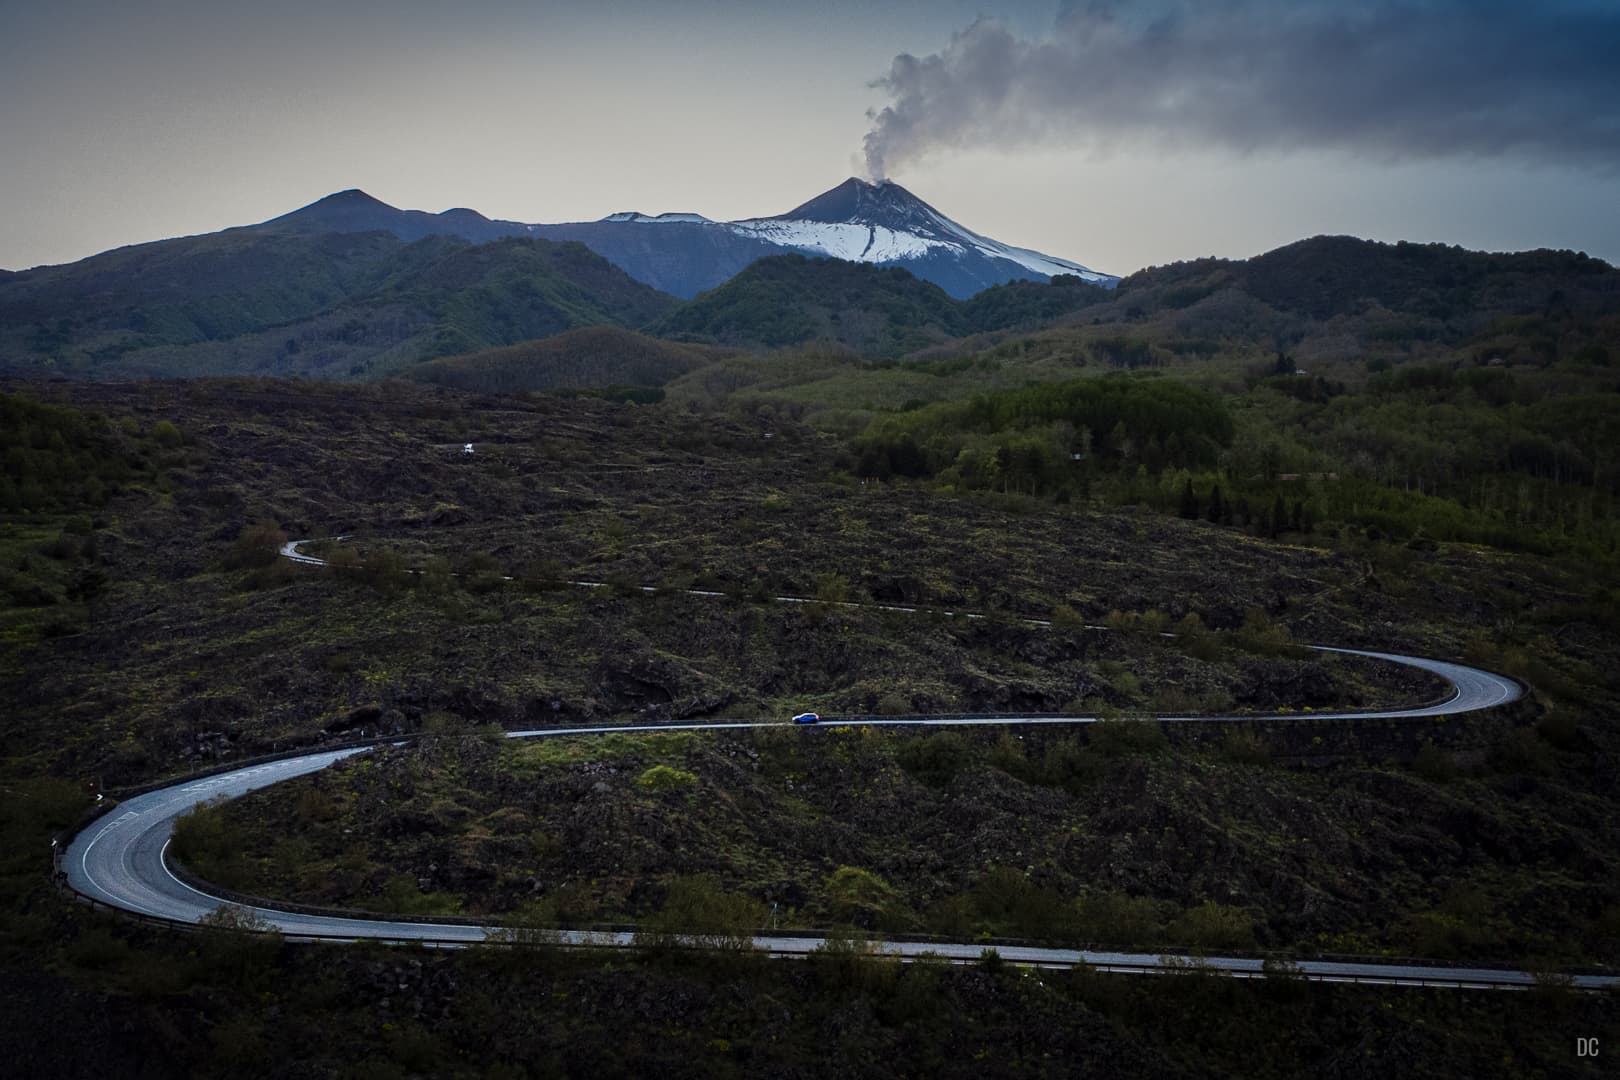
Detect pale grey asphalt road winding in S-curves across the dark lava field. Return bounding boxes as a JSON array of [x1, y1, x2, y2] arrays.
[[60, 541, 1620, 989]]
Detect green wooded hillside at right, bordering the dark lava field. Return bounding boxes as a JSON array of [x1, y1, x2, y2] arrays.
[[635, 238, 1620, 559]]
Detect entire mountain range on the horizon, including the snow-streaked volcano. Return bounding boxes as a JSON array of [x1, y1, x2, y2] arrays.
[[0, 187, 1620, 379]]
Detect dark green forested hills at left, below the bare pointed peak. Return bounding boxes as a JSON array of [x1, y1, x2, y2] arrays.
[[0, 230, 676, 379]]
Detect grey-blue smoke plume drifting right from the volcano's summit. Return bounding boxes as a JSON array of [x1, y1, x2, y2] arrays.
[[865, 0, 1620, 176]]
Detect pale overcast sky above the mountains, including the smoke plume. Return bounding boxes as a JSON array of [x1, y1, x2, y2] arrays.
[[0, 0, 1620, 274]]
